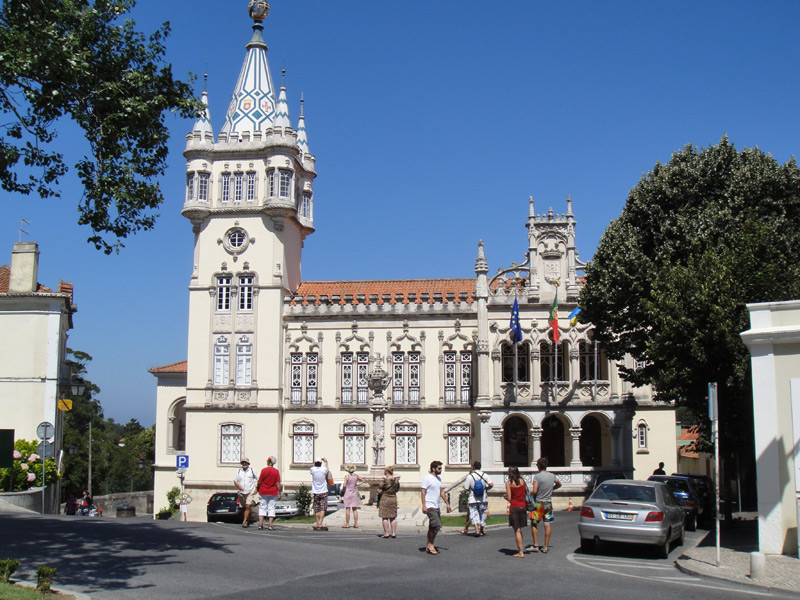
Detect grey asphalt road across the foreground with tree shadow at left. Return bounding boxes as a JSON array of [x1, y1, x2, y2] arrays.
[[0, 512, 797, 600]]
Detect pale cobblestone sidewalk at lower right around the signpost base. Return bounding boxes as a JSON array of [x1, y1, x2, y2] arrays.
[[675, 521, 800, 594]]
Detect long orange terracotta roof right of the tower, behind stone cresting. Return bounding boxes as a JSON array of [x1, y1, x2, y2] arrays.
[[290, 279, 475, 306]]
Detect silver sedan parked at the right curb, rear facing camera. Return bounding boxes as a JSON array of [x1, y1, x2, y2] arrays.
[[578, 479, 684, 558]]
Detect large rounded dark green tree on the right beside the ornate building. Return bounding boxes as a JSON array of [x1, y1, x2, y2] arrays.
[[580, 137, 800, 448]]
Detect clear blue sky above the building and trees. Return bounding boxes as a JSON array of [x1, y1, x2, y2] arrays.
[[0, 0, 800, 426]]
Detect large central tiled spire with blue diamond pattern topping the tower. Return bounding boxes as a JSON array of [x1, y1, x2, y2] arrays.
[[220, 0, 277, 139]]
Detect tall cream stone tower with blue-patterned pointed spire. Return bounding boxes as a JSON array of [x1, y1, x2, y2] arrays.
[[182, 0, 316, 468]]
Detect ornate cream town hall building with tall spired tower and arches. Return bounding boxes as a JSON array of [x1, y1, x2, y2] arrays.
[[151, 2, 676, 520]]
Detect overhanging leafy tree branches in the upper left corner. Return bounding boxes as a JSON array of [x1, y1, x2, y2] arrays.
[[0, 0, 201, 254]]
